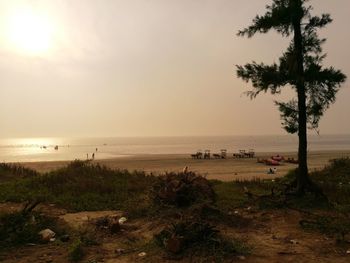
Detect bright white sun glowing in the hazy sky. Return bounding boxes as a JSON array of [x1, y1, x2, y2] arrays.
[[8, 9, 52, 55]]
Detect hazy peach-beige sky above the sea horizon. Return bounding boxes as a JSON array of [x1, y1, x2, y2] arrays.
[[0, 0, 350, 137]]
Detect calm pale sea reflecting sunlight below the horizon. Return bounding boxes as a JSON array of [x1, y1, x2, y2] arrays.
[[0, 135, 350, 162]]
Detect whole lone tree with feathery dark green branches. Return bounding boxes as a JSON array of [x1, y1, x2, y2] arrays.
[[237, 0, 346, 193]]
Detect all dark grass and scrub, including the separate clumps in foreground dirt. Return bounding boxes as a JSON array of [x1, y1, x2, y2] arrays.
[[0, 158, 350, 258]]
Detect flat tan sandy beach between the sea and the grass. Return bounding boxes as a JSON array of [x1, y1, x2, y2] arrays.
[[19, 151, 350, 181]]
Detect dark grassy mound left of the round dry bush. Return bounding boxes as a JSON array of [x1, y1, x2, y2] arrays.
[[0, 161, 154, 214]]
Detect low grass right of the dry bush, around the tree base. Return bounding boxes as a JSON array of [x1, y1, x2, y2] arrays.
[[212, 158, 350, 214]]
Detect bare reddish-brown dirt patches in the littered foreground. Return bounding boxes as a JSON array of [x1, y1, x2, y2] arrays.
[[0, 203, 350, 263]]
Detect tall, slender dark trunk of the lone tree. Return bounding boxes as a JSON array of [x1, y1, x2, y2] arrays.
[[291, 0, 310, 193]]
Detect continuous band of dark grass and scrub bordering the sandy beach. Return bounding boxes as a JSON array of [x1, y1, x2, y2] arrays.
[[0, 158, 350, 217]]
